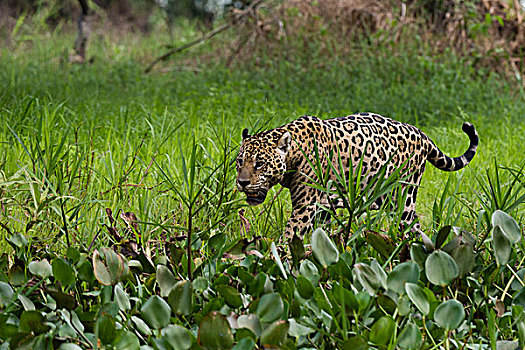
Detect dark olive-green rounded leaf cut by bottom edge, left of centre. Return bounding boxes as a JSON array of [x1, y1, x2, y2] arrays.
[[197, 311, 233, 349]]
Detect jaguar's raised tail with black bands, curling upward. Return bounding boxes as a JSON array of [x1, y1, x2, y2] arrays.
[[427, 123, 479, 171]]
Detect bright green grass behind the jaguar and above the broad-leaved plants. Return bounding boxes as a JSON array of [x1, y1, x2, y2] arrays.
[[0, 26, 525, 250]]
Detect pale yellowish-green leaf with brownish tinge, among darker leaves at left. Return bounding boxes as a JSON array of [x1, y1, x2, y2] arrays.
[[93, 247, 129, 286]]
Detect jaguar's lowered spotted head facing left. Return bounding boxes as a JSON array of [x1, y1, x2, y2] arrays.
[[237, 129, 292, 205]]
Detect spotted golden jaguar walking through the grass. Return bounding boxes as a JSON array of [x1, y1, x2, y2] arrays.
[[237, 113, 479, 237]]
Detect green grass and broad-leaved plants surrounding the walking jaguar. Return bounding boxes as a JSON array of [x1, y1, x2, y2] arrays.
[[0, 2, 525, 349]]
